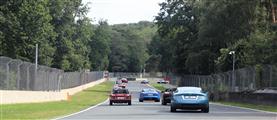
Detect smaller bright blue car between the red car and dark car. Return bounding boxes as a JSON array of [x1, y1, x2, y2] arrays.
[[139, 88, 160, 102]]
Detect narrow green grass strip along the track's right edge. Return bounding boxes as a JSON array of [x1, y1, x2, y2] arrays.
[[218, 101, 277, 112]]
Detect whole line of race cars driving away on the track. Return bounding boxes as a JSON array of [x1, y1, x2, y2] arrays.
[[110, 78, 209, 113]]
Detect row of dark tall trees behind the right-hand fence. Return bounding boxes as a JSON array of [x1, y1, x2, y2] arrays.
[[147, 0, 277, 74]]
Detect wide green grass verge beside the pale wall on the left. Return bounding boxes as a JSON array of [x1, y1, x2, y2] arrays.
[[0, 82, 113, 120]]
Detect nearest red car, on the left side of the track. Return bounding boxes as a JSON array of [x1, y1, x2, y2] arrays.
[[110, 88, 132, 105]]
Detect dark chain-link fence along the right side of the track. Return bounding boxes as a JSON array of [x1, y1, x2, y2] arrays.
[[167, 65, 277, 92]]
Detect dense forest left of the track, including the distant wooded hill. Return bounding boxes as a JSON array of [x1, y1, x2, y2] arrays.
[[0, 0, 156, 72]]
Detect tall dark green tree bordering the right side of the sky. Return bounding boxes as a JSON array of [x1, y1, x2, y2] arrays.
[[153, 0, 199, 73]]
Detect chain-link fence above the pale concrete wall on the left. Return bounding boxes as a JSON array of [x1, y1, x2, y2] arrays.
[[0, 56, 104, 91]]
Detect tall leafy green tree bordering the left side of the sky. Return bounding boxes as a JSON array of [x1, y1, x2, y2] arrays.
[[49, 0, 89, 71]]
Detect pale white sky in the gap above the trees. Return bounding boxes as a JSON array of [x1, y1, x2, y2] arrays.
[[82, 0, 165, 24]]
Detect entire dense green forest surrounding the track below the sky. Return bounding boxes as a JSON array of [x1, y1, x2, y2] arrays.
[[0, 0, 277, 74]]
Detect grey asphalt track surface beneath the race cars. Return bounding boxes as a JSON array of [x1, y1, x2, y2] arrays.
[[60, 81, 277, 120]]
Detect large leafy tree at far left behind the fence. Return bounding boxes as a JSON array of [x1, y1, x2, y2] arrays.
[[0, 0, 55, 65]]
